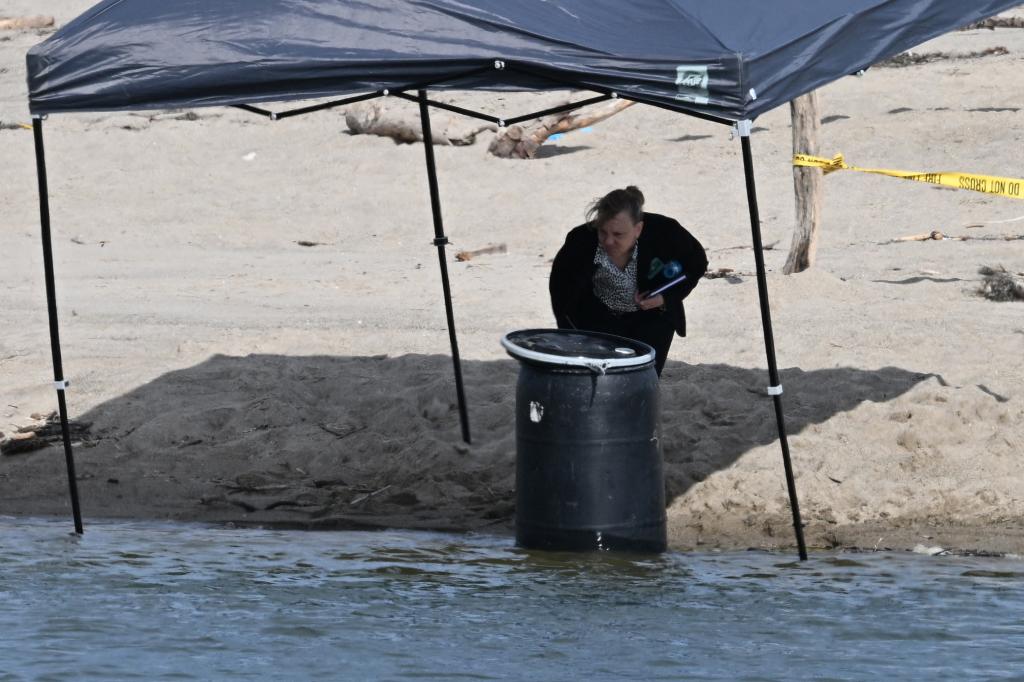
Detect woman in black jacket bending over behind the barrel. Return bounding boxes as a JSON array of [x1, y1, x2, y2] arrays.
[[549, 185, 708, 376]]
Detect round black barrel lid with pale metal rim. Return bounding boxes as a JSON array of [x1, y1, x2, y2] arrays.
[[502, 329, 654, 373]]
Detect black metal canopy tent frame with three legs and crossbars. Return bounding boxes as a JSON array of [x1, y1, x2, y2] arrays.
[[33, 71, 807, 560]]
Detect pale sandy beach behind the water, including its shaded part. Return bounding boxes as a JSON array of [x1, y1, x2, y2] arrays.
[[0, 0, 1024, 553]]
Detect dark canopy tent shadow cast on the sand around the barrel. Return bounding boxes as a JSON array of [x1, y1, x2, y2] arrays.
[[4, 355, 933, 530]]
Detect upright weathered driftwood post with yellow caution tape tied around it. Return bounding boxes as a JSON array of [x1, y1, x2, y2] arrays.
[[782, 91, 822, 274]]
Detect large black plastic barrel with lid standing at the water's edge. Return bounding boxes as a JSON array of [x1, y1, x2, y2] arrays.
[[502, 330, 667, 552]]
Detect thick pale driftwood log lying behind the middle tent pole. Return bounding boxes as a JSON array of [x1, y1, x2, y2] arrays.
[[345, 99, 498, 146]]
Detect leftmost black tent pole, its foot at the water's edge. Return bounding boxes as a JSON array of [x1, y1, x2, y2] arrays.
[[32, 116, 84, 535]]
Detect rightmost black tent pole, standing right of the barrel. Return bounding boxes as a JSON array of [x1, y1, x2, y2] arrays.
[[737, 121, 807, 561]]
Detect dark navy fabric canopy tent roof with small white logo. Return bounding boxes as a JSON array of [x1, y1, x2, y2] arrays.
[[28, 0, 1020, 121]]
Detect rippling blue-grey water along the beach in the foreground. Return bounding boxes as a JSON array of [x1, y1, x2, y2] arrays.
[[0, 518, 1024, 680]]
